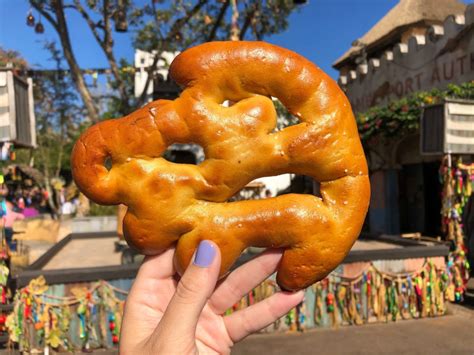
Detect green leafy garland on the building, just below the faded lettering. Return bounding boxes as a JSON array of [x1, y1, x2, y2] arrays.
[[356, 81, 474, 142]]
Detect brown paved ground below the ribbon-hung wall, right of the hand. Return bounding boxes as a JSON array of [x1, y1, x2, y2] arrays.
[[232, 306, 474, 355]]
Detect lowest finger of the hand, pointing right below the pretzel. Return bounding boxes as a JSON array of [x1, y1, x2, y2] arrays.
[[224, 291, 304, 343]]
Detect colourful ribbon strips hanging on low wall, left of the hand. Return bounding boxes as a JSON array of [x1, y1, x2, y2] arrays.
[[6, 276, 127, 353]]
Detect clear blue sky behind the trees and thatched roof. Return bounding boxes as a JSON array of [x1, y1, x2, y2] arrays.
[[0, 0, 474, 78]]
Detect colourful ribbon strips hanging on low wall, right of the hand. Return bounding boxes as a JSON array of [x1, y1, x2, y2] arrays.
[[228, 259, 454, 331]]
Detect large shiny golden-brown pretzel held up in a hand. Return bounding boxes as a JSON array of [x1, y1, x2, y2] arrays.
[[72, 42, 370, 290]]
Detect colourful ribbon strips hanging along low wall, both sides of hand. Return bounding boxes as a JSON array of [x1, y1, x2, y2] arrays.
[[6, 258, 457, 352]]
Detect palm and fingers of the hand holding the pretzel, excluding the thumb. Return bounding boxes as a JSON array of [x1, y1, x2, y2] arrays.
[[122, 250, 301, 354]]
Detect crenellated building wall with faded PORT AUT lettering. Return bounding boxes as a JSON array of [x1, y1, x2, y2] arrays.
[[339, 12, 474, 112]]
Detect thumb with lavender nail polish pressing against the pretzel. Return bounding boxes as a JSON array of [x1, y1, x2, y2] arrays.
[[159, 240, 221, 338]]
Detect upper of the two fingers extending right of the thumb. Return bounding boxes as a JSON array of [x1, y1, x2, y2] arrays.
[[209, 250, 282, 314]]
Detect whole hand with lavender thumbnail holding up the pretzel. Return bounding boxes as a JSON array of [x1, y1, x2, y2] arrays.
[[120, 241, 304, 355]]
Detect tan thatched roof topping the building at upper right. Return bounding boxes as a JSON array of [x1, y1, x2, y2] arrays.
[[333, 0, 466, 68]]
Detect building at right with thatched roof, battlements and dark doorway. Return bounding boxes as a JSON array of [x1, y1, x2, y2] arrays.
[[333, 0, 474, 236]]
